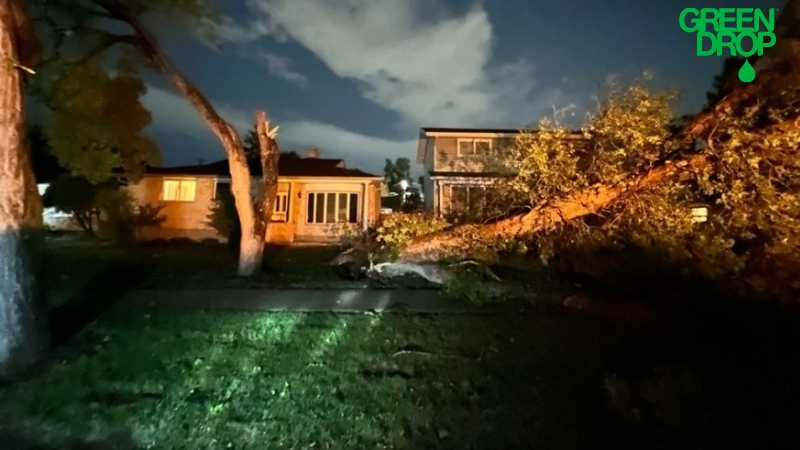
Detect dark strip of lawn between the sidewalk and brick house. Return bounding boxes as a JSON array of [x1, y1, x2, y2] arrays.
[[43, 242, 352, 302]]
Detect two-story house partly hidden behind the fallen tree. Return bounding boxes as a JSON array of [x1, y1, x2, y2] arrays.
[[417, 128, 520, 220]]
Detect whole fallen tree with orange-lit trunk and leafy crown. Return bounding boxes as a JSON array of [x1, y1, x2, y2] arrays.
[[400, 2, 800, 298]]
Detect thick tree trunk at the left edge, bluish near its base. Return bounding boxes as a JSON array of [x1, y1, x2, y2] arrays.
[[0, 0, 47, 377]]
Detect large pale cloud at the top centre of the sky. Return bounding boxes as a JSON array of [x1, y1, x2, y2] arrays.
[[219, 0, 564, 127]]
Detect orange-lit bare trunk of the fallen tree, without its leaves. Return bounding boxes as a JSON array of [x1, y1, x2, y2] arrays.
[[399, 0, 800, 263]]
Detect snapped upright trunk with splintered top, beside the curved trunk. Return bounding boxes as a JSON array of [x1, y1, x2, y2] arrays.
[[256, 111, 280, 246]]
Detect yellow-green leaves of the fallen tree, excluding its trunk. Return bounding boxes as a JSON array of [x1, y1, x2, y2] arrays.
[[499, 73, 800, 298]]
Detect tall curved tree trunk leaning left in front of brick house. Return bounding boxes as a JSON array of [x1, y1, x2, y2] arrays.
[[95, 0, 264, 277]]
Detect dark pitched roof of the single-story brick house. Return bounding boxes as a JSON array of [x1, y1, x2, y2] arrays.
[[147, 157, 381, 178]]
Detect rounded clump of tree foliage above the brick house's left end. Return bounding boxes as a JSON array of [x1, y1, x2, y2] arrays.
[[45, 61, 160, 183]]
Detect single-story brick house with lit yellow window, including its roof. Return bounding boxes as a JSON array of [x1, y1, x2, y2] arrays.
[[128, 156, 383, 244]]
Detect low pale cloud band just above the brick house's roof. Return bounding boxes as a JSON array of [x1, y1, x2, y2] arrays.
[[142, 86, 416, 173]]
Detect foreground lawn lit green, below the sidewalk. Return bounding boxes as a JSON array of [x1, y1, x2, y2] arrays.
[[0, 308, 648, 449]]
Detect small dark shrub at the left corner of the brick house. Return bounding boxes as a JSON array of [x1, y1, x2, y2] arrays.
[[98, 190, 164, 243]]
